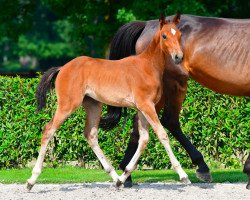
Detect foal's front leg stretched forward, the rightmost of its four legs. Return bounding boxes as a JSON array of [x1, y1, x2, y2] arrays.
[[139, 103, 190, 183]]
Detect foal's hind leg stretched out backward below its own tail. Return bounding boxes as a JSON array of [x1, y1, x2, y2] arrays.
[[27, 106, 74, 191]]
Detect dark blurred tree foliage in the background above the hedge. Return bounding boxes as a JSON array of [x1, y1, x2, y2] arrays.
[[0, 0, 250, 71]]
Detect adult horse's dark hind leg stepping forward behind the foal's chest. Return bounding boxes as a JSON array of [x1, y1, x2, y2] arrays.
[[161, 77, 212, 182]]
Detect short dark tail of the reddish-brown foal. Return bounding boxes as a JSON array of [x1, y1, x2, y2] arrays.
[[36, 67, 60, 111]]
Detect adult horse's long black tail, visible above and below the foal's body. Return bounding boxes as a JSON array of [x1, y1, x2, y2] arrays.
[[100, 21, 146, 130]]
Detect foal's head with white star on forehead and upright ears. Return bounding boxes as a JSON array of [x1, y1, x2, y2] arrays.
[[159, 13, 183, 64]]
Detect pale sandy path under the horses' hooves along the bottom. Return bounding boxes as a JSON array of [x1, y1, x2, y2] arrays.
[[0, 183, 250, 200]]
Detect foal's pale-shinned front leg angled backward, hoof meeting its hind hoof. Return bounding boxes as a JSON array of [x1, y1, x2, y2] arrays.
[[117, 112, 149, 186]]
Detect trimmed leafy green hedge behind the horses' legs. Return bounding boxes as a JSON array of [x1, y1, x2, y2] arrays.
[[0, 76, 250, 169]]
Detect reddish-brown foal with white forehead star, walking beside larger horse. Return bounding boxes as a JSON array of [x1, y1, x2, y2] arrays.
[[27, 14, 190, 190]]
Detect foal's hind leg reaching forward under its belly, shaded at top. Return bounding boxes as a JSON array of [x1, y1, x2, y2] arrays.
[[83, 97, 118, 182]]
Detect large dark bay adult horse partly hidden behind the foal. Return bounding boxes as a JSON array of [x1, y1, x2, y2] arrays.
[[101, 15, 250, 189]]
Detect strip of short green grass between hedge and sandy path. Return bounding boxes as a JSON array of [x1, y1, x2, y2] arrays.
[[0, 167, 247, 184]]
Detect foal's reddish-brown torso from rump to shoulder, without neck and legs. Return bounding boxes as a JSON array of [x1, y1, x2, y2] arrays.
[[56, 56, 158, 107]]
